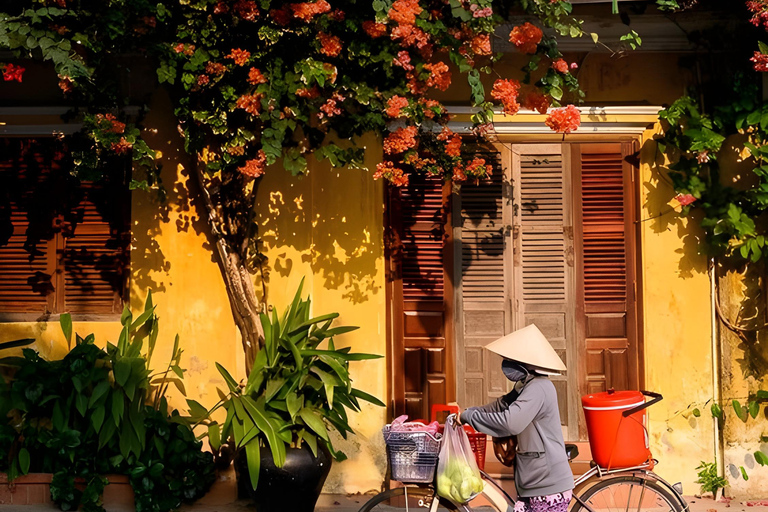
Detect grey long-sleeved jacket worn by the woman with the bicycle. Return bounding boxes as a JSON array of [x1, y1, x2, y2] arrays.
[[461, 377, 573, 498]]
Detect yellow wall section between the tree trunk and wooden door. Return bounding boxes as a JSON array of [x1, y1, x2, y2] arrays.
[[258, 137, 387, 493]]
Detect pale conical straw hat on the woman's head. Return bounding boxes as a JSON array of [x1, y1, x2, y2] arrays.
[[485, 324, 566, 372]]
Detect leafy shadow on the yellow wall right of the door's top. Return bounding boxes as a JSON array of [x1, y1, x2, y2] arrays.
[[640, 140, 707, 279]]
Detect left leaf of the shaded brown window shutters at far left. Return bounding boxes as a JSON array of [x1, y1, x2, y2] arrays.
[[0, 138, 56, 315]]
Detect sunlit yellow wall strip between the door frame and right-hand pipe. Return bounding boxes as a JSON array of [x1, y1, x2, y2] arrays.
[[640, 125, 715, 494]]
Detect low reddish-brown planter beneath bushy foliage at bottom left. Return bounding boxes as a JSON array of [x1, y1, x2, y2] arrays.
[[0, 473, 134, 511]]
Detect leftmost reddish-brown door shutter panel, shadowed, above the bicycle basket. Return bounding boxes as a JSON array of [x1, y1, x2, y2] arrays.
[[389, 175, 453, 419]]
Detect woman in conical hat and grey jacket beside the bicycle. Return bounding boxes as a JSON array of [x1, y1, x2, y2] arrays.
[[457, 325, 574, 512]]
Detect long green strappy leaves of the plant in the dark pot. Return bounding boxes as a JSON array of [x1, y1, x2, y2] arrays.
[[208, 286, 384, 489]]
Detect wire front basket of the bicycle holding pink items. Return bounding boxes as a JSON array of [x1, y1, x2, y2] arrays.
[[382, 425, 442, 483]]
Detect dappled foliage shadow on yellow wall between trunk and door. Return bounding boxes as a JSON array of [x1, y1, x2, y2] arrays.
[[256, 152, 383, 304]]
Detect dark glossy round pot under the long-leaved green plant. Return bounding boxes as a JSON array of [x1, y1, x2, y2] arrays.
[[235, 445, 332, 512]]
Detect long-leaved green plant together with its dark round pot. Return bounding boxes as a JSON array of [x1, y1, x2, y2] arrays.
[[208, 286, 384, 512]]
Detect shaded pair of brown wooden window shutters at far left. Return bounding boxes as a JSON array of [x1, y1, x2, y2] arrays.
[[0, 138, 130, 320]]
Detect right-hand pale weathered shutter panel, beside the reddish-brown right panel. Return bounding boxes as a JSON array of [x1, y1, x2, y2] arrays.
[[512, 144, 579, 438]]
